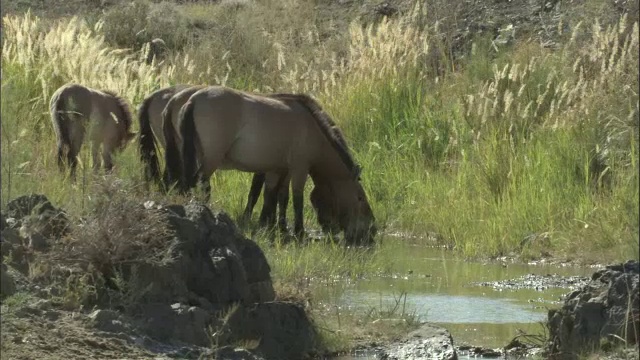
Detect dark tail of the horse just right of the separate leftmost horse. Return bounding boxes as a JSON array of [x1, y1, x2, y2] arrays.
[[138, 96, 160, 181]]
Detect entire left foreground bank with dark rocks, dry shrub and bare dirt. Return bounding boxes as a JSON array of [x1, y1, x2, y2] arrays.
[[1, 191, 317, 359]]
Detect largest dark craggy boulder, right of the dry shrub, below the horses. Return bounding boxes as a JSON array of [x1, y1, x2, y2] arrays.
[[124, 204, 275, 311]]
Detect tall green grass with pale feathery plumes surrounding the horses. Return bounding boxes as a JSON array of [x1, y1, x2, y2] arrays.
[[2, 3, 639, 268]]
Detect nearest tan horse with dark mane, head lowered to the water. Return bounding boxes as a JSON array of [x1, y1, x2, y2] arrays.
[[167, 86, 377, 242]]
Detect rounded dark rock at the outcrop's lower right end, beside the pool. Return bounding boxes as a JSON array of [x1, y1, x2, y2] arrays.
[[221, 302, 316, 360]]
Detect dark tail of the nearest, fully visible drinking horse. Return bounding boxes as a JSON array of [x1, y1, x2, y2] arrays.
[[180, 100, 199, 189]]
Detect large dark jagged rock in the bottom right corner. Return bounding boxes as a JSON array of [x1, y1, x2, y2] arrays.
[[547, 261, 640, 359]]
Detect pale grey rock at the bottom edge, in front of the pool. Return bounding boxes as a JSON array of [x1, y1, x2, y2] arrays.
[[380, 324, 458, 360]]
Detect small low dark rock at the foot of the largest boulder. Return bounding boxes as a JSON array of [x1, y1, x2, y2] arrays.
[[140, 303, 211, 346]]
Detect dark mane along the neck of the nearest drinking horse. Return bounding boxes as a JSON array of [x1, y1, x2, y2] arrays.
[[268, 93, 359, 173]]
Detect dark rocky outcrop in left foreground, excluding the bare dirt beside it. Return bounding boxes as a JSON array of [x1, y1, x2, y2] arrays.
[[0, 195, 316, 359]]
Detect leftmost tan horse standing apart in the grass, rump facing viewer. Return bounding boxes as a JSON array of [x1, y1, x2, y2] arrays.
[[49, 83, 136, 179]]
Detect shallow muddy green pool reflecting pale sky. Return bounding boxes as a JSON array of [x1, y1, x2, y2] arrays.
[[316, 239, 594, 359]]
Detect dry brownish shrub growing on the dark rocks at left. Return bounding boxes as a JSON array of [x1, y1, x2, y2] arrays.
[[37, 182, 177, 307]]
